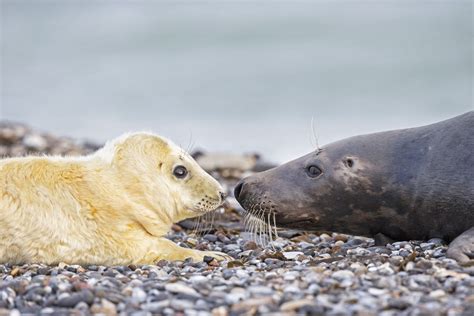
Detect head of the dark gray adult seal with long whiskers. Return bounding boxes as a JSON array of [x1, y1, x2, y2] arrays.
[[235, 133, 418, 237]]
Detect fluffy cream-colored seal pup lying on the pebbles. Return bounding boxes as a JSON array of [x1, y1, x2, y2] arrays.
[[0, 133, 230, 265]]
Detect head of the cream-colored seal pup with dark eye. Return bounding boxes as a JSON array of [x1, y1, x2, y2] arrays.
[[95, 132, 225, 222]]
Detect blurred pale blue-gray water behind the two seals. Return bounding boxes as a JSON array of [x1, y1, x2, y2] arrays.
[[0, 0, 474, 162]]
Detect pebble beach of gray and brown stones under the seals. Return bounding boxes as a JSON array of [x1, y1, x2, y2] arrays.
[[0, 122, 474, 316]]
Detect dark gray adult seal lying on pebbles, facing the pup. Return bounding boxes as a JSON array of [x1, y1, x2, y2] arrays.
[[234, 111, 474, 262]]
